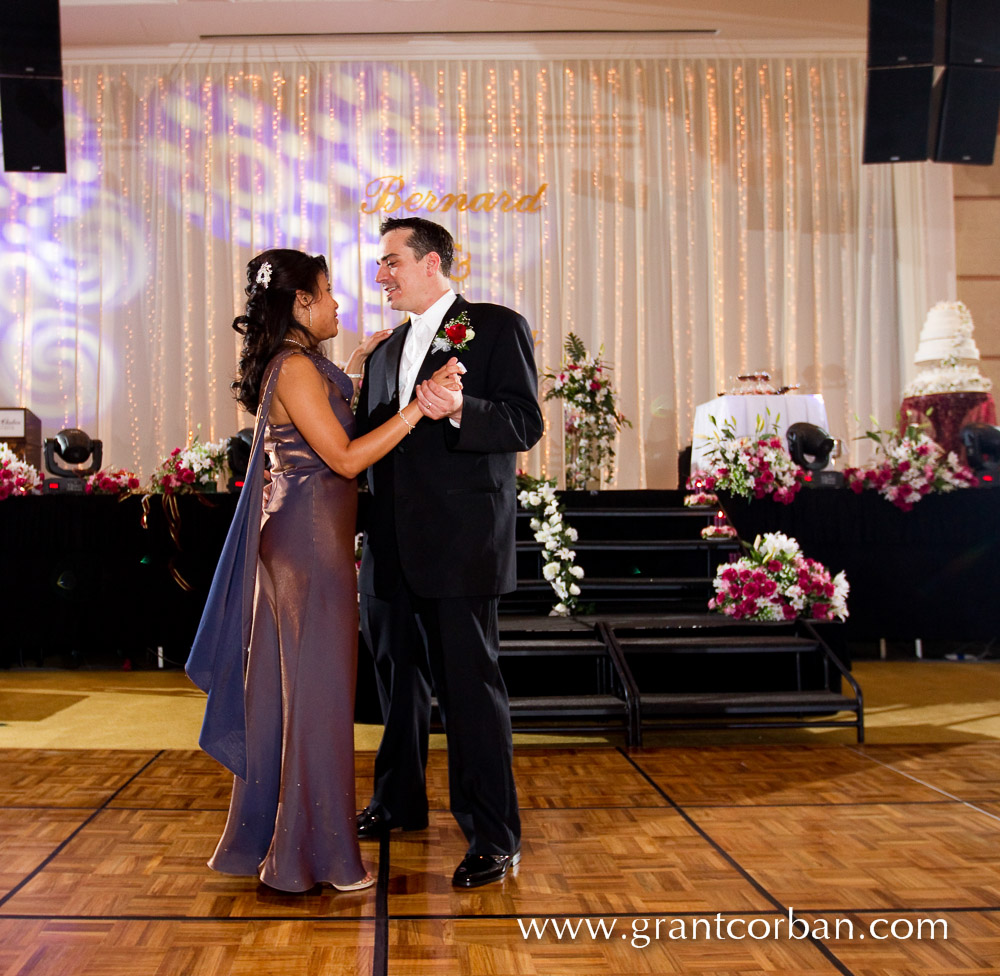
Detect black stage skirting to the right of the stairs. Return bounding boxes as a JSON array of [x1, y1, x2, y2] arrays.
[[719, 488, 1000, 641]]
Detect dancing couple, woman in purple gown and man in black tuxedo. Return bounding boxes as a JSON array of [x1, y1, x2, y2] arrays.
[[187, 218, 542, 891]]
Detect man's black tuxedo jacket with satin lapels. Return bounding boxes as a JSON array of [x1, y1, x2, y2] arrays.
[[357, 295, 542, 599]]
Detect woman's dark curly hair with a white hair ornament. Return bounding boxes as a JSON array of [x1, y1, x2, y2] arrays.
[[232, 248, 330, 413]]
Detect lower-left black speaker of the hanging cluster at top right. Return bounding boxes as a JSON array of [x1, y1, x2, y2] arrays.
[[862, 65, 934, 163]]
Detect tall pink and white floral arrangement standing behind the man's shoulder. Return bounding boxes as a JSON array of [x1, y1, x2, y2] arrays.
[[542, 332, 632, 488]]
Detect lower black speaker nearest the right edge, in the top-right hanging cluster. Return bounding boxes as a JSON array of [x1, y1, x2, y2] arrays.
[[934, 65, 1000, 166]]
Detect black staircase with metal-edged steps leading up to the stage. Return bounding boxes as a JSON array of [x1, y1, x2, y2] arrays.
[[500, 491, 864, 746]]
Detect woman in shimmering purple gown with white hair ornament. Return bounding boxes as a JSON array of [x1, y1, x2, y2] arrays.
[[187, 249, 460, 891]]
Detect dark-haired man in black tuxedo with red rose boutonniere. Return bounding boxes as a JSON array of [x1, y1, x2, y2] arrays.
[[357, 217, 542, 888]]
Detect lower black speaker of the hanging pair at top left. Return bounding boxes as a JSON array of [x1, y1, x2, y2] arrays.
[[0, 78, 66, 173]]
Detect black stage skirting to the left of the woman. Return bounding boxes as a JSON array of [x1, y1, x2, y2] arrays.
[[0, 494, 238, 666]]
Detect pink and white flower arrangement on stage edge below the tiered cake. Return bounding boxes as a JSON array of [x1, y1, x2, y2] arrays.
[[844, 424, 976, 512]]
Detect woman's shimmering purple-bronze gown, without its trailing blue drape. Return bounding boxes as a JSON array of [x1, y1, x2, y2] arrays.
[[209, 351, 365, 891]]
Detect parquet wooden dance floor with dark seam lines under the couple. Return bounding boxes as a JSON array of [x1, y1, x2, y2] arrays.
[[0, 741, 1000, 976]]
